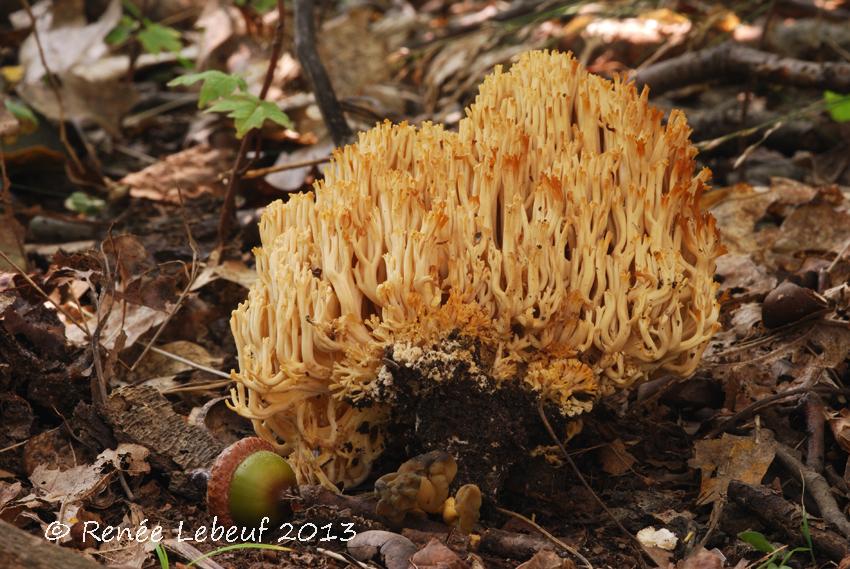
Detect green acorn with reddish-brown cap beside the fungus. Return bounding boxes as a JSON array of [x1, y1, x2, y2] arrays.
[[207, 437, 298, 527]]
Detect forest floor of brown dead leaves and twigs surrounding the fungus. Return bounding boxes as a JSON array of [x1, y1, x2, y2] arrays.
[[0, 0, 850, 569]]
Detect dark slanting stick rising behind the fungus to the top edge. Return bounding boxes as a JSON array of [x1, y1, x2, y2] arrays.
[[293, 0, 354, 146]]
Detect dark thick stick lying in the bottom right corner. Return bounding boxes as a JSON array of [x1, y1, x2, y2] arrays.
[[728, 480, 850, 561]]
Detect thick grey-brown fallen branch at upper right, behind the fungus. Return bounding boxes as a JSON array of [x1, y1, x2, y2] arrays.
[[634, 42, 850, 95]]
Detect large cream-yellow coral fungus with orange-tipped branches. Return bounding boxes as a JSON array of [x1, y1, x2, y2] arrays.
[[232, 52, 721, 486]]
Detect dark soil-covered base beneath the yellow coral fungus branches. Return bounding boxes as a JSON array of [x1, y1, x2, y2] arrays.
[[370, 334, 566, 497]]
